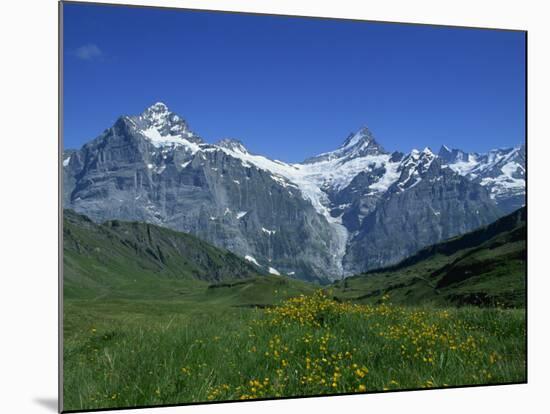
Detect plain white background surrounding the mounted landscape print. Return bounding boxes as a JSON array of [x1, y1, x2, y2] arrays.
[[0, 0, 550, 414]]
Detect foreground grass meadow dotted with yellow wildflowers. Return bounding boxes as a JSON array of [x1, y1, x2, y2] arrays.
[[64, 288, 526, 410]]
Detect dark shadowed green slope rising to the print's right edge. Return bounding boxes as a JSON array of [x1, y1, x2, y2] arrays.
[[333, 207, 527, 307]]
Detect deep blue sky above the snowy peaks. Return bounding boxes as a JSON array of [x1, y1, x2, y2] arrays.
[[63, 4, 525, 162]]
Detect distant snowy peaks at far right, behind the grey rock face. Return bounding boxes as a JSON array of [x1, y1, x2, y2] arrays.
[[438, 145, 526, 212]]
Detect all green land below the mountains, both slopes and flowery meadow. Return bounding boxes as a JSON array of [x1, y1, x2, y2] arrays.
[[63, 213, 526, 411]]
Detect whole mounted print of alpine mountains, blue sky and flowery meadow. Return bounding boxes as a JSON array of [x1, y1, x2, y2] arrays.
[[60, 2, 527, 412]]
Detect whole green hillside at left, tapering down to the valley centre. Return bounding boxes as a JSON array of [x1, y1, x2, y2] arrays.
[[63, 210, 312, 305]]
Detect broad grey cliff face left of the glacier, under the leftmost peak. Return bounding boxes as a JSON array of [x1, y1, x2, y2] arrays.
[[64, 105, 341, 280]]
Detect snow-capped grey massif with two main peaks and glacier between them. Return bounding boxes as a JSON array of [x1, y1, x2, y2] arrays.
[[63, 103, 519, 282]]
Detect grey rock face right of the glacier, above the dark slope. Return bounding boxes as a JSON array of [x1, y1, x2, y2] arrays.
[[344, 153, 501, 274]]
